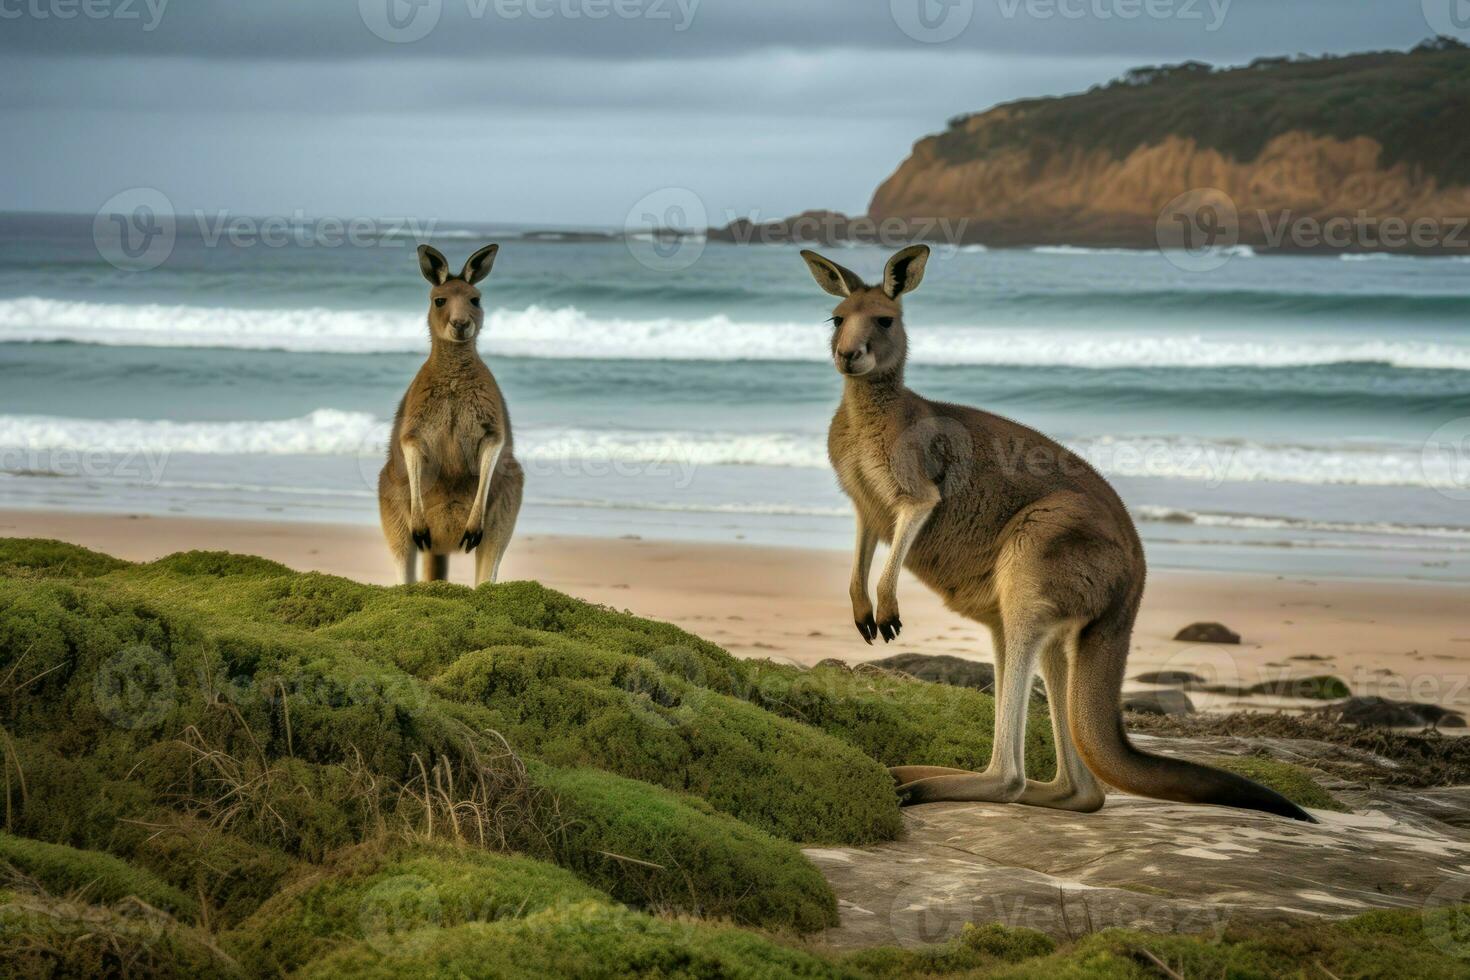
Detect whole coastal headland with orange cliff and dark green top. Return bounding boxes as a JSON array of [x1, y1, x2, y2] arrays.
[[867, 38, 1470, 253]]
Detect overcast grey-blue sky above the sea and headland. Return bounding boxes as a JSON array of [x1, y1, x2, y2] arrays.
[[0, 0, 1455, 226]]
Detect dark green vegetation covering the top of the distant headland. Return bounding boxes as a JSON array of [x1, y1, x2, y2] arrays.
[[933, 38, 1470, 187]]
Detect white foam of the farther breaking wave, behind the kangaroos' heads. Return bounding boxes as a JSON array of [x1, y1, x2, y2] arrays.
[[0, 297, 1470, 370]]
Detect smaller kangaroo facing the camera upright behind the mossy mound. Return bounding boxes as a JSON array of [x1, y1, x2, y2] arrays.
[[378, 245, 525, 585]]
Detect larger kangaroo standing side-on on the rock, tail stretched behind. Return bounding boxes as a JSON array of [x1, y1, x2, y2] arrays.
[[801, 245, 1311, 820]]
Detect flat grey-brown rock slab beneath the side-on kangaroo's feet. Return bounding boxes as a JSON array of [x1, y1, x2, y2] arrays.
[[806, 789, 1470, 948]]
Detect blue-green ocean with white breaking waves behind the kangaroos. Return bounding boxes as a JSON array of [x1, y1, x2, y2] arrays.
[[0, 215, 1470, 580]]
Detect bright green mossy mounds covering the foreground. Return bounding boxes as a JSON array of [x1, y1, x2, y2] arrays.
[[0, 539, 1458, 979]]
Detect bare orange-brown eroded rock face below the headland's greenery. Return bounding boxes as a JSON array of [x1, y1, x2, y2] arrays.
[[869, 128, 1470, 248]]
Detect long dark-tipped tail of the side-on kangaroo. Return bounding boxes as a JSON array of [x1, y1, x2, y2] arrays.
[[1067, 613, 1316, 823]]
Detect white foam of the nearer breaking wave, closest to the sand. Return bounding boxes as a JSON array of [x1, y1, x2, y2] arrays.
[[0, 408, 1466, 489]]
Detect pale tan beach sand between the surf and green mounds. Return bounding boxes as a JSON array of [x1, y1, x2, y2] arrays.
[[0, 511, 1470, 710]]
